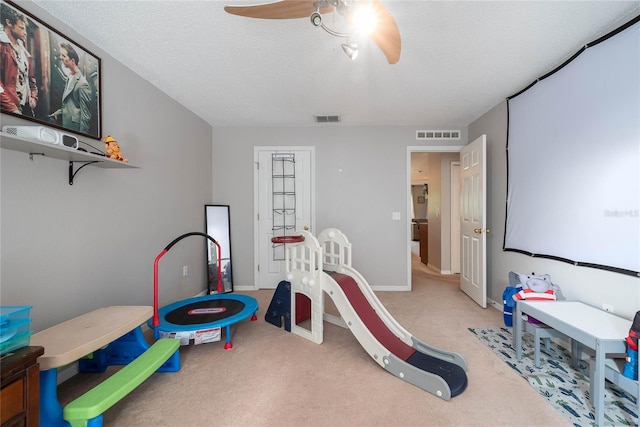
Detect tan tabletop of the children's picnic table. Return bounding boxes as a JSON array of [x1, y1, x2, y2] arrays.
[[30, 306, 153, 370]]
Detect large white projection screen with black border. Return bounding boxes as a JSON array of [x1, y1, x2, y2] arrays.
[[503, 16, 640, 276]]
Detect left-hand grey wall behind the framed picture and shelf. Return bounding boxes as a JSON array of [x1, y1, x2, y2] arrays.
[[0, 2, 212, 331]]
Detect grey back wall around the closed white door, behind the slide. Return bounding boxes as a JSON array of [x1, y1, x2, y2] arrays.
[[213, 124, 466, 290]]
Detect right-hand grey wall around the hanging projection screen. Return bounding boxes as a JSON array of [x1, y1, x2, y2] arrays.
[[469, 101, 640, 319]]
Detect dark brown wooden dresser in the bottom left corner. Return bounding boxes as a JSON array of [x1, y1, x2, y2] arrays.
[[0, 347, 44, 427]]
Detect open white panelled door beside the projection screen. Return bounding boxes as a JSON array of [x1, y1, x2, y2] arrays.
[[460, 135, 489, 308]]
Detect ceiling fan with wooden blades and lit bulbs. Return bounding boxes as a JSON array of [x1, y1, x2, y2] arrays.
[[224, 0, 401, 64]]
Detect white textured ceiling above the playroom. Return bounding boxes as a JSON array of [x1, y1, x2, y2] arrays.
[[36, 0, 640, 129]]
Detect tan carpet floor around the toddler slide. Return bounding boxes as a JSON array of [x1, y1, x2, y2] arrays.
[[59, 257, 570, 427]]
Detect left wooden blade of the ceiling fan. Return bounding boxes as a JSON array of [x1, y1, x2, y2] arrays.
[[224, 0, 333, 19]]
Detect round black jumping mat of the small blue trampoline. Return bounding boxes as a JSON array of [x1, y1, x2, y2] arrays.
[[164, 298, 244, 325]]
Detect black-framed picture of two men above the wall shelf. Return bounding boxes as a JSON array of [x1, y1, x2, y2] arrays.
[[0, 0, 102, 139]]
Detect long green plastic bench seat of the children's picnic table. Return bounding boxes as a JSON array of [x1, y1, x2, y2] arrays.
[[63, 338, 180, 427]]
